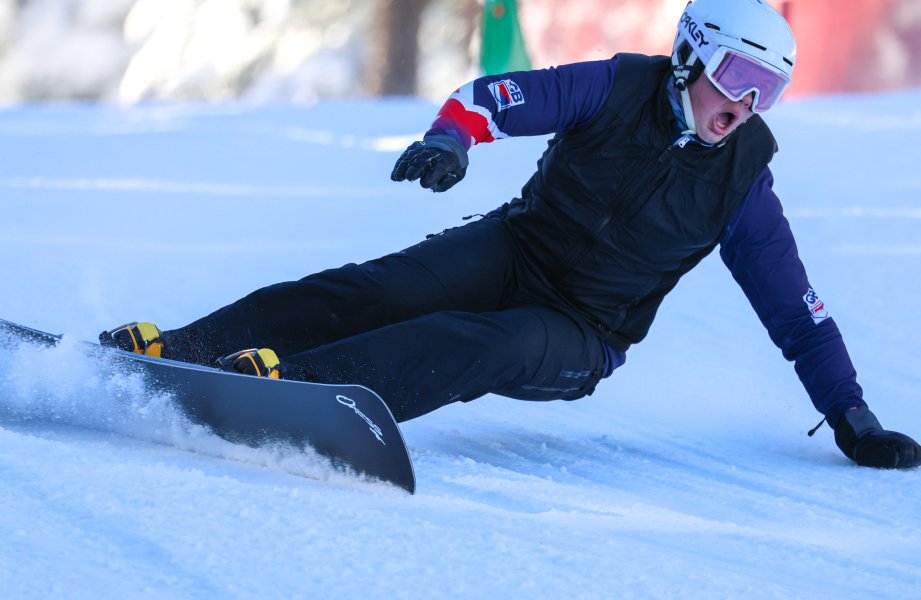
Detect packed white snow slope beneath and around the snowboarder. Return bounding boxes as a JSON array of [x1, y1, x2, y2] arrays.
[[0, 91, 921, 599]]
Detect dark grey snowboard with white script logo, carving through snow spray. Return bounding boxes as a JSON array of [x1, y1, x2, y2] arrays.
[[0, 319, 416, 493]]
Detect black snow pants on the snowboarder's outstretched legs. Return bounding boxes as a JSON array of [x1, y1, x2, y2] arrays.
[[164, 218, 605, 421]]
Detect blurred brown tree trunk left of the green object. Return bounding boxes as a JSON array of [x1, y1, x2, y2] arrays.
[[365, 0, 429, 96]]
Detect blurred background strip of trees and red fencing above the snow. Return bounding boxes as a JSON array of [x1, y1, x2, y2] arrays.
[[0, 0, 921, 104]]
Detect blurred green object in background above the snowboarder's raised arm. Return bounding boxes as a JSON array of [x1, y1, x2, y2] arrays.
[[480, 0, 531, 75]]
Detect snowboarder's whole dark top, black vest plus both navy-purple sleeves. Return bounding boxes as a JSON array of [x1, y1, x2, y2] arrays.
[[429, 54, 865, 423]]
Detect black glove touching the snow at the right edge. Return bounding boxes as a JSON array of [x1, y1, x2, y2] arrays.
[[835, 406, 921, 469]]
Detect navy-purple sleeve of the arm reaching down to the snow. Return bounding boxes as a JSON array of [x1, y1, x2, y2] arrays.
[[720, 168, 865, 426]]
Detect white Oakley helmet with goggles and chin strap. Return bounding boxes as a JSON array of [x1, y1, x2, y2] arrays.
[[672, 0, 796, 132]]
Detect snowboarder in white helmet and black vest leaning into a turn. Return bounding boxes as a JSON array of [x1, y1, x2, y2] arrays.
[[100, 0, 921, 468]]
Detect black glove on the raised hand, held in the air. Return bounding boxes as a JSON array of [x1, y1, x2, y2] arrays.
[[390, 135, 469, 192]]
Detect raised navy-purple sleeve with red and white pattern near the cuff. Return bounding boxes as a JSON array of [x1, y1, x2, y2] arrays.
[[426, 58, 617, 149]]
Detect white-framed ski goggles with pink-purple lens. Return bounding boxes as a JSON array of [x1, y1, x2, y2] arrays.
[[704, 46, 790, 113]]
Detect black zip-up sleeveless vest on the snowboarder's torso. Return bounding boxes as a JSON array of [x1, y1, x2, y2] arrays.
[[508, 54, 777, 350]]
